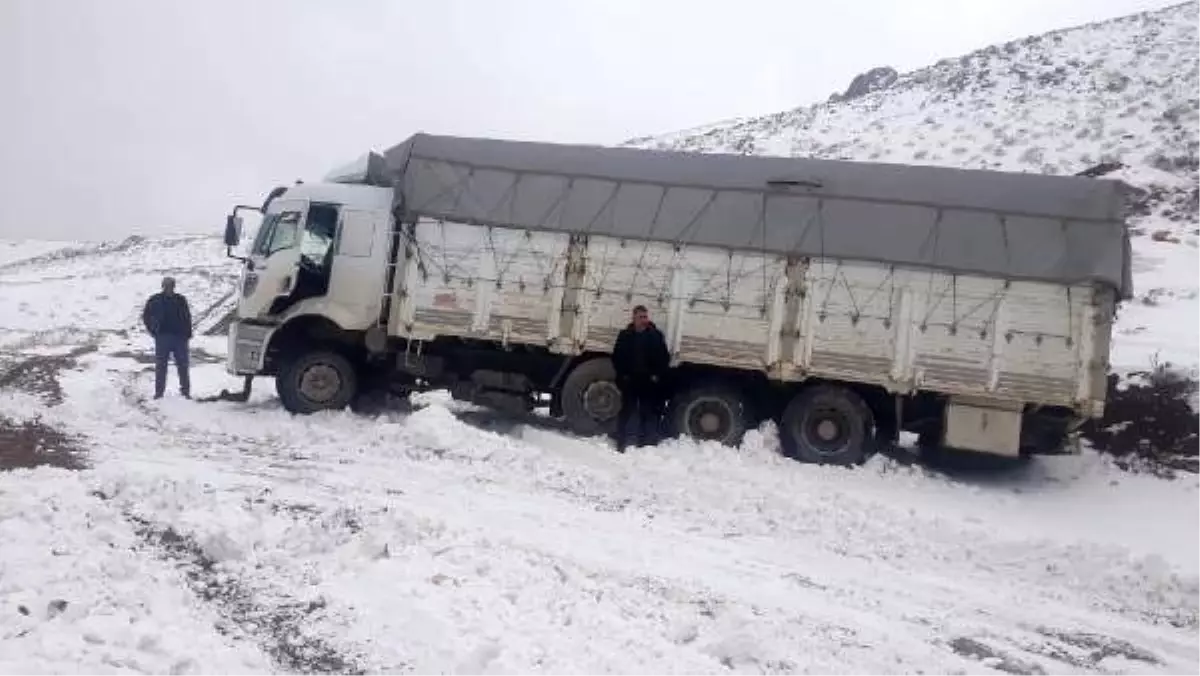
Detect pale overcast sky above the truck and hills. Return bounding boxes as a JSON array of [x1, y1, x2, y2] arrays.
[[0, 0, 1175, 239]]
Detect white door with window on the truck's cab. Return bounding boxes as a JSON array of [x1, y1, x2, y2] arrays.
[[239, 199, 308, 318]]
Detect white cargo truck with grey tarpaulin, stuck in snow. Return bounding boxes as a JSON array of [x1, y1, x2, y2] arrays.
[[224, 133, 1133, 465]]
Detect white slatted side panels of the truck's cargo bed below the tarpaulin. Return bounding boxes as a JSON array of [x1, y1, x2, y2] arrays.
[[389, 221, 1115, 411]]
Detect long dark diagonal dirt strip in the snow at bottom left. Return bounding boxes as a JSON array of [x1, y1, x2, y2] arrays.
[[118, 509, 366, 674]]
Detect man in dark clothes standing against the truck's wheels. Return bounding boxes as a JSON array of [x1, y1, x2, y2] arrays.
[[612, 305, 671, 453]]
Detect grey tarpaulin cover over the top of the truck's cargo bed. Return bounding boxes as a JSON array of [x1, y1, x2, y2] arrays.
[[377, 134, 1133, 298]]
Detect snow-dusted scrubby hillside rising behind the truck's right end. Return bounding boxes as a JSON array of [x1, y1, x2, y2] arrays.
[[630, 1, 1200, 369]]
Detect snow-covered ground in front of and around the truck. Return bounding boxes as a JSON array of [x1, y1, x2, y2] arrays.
[[0, 231, 1200, 674]]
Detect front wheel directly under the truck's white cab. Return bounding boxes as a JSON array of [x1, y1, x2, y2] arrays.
[[275, 351, 359, 415]]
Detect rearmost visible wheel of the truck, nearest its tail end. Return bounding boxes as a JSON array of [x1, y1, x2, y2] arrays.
[[779, 385, 876, 466]]
